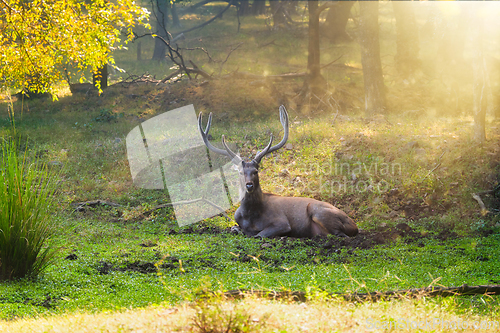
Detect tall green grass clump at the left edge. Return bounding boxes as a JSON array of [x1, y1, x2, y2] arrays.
[[0, 139, 55, 281]]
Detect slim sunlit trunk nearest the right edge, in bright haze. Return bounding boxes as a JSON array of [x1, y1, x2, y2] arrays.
[[469, 4, 487, 143]]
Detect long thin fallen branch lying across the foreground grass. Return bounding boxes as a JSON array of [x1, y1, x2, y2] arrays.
[[220, 284, 500, 302]]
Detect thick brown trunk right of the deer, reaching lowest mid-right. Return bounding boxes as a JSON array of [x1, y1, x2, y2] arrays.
[[359, 1, 386, 117]]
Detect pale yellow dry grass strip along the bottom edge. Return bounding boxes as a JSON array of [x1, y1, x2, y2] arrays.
[[5, 298, 499, 332]]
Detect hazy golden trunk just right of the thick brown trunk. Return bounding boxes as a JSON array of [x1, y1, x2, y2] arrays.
[[392, 1, 420, 79]]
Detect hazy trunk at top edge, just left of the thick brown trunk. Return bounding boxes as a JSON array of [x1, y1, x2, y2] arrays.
[[323, 1, 354, 42]]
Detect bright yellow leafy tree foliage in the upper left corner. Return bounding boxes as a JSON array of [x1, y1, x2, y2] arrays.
[[0, 0, 149, 96]]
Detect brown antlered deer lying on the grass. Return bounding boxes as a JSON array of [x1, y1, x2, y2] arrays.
[[198, 105, 358, 238]]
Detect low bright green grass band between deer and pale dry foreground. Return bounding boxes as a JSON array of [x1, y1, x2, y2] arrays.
[[0, 213, 500, 319]]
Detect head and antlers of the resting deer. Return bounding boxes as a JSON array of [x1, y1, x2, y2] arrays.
[[198, 105, 288, 194]]
